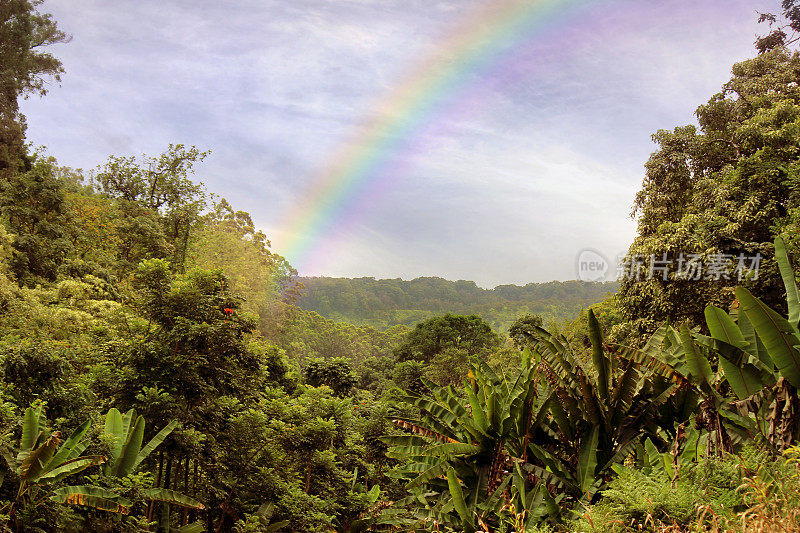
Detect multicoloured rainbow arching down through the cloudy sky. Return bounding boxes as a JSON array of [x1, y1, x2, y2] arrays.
[[274, 0, 602, 273]]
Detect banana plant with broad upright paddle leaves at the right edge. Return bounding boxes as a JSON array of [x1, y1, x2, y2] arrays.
[[636, 238, 800, 452]]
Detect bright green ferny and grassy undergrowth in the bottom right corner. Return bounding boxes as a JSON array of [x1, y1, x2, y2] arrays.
[[568, 447, 800, 533]]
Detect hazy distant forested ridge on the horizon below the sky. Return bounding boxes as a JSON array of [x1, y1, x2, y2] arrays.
[[298, 277, 618, 333]]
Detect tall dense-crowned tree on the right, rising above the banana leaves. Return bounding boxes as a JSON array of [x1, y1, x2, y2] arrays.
[[618, 43, 800, 335]]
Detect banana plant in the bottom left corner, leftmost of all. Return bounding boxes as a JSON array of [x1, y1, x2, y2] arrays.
[[1, 405, 130, 522]]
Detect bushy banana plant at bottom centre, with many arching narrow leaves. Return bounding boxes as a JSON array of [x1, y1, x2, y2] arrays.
[[381, 352, 557, 532]]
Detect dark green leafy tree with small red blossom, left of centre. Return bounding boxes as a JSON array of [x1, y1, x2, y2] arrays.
[[116, 259, 264, 522]]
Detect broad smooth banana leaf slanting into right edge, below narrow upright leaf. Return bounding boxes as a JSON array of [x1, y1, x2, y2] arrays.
[[736, 287, 800, 387]]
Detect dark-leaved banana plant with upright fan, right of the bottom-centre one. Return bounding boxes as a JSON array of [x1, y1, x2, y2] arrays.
[[525, 309, 677, 503]]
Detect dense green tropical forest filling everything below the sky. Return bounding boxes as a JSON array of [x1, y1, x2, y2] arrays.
[[0, 0, 800, 533]]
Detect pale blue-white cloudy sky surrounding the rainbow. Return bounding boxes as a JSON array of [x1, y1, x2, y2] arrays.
[[22, 0, 779, 287]]
